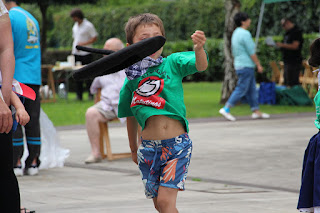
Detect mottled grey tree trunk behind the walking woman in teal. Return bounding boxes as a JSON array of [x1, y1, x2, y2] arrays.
[[220, 0, 241, 103]]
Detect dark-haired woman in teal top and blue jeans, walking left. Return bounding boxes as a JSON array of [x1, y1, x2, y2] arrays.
[[219, 12, 270, 121]]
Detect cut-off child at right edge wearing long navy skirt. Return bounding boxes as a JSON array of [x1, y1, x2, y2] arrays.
[[298, 38, 320, 213]]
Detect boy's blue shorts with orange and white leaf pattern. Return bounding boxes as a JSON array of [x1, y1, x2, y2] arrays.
[[138, 133, 192, 198]]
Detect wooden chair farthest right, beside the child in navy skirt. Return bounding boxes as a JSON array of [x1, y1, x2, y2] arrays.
[[301, 61, 318, 98]]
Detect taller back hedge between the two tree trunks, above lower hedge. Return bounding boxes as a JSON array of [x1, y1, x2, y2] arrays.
[[48, 1, 224, 47]]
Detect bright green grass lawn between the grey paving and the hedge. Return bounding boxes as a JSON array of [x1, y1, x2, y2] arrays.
[[41, 82, 315, 126]]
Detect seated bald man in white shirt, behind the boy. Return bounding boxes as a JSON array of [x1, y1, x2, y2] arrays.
[[85, 38, 126, 164]]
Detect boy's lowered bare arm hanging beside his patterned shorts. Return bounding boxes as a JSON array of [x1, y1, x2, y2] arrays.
[[127, 116, 138, 164]]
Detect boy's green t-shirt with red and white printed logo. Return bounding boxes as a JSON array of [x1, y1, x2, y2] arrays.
[[118, 51, 202, 132]]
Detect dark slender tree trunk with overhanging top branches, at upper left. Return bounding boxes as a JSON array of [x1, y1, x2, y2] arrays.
[[19, 0, 97, 53]]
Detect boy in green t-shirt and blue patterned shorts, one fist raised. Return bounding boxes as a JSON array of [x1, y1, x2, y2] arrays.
[[118, 13, 208, 212]]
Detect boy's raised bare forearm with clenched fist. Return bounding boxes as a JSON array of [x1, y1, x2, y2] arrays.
[[191, 30, 208, 72]]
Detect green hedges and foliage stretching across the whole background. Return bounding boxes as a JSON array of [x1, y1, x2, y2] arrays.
[[23, 0, 320, 81]]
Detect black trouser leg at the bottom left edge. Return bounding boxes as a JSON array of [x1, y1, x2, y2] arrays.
[[0, 132, 20, 213]]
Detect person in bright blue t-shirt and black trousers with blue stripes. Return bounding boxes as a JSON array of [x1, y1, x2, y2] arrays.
[[5, 0, 42, 176]]
